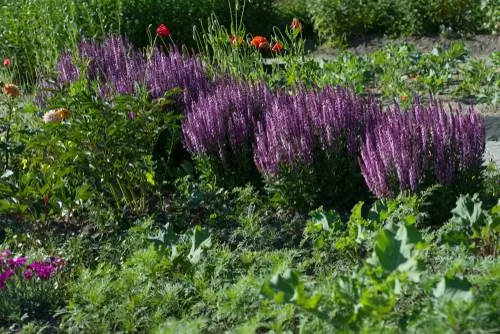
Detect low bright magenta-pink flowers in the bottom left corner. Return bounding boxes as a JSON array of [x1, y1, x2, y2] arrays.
[[0, 250, 66, 290]]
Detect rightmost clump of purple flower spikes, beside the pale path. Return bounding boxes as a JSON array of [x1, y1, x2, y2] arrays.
[[360, 98, 485, 198]]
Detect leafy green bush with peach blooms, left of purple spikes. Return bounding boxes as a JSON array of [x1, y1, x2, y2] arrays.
[[0, 75, 180, 228]]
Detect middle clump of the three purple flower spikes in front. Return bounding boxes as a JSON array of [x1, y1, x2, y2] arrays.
[[254, 87, 369, 176]]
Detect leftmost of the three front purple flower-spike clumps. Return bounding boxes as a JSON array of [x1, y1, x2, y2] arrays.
[[182, 79, 270, 163]]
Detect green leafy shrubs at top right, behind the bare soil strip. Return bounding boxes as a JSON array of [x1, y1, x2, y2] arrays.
[[307, 0, 495, 43]]
